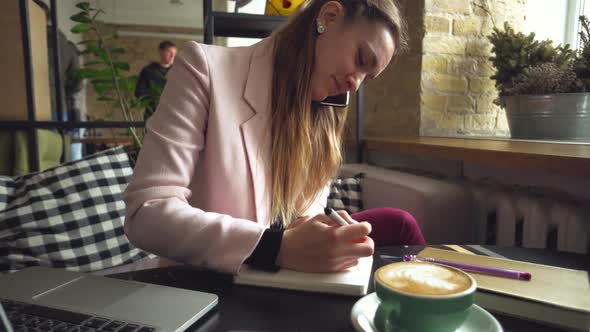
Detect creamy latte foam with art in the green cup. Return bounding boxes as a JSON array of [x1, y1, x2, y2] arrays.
[[377, 262, 471, 295]]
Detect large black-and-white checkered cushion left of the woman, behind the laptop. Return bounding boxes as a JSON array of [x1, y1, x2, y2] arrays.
[[0, 147, 147, 272]]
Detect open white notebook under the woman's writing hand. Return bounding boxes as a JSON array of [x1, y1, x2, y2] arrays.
[[234, 257, 373, 295]]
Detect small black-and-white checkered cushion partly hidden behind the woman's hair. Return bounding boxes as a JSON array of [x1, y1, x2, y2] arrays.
[[327, 173, 365, 213]]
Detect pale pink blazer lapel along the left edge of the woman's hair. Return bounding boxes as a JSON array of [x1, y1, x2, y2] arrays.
[[240, 38, 272, 225]]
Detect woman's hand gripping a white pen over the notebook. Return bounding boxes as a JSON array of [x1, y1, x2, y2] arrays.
[[277, 214, 374, 272]]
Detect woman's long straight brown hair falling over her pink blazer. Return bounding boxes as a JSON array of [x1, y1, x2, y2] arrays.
[[270, 0, 405, 226]]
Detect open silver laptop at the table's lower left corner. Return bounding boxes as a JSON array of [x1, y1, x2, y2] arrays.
[[0, 267, 218, 332]]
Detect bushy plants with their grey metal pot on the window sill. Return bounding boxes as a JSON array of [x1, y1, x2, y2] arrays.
[[489, 17, 590, 140]]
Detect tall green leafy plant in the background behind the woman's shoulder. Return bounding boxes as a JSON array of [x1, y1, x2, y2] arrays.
[[70, 2, 150, 148]]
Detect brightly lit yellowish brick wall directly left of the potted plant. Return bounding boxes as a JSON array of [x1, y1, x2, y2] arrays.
[[420, 0, 526, 136]]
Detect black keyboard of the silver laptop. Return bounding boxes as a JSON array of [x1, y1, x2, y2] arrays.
[[0, 300, 156, 332]]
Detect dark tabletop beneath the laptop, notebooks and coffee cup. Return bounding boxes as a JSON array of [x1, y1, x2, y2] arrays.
[[101, 246, 590, 332]]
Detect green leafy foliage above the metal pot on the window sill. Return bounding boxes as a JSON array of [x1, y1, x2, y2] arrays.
[[488, 23, 576, 97]]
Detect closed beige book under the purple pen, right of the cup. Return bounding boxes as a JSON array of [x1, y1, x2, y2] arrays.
[[419, 248, 590, 331]]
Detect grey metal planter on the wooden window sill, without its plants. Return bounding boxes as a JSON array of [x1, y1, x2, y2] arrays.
[[502, 93, 590, 141]]
